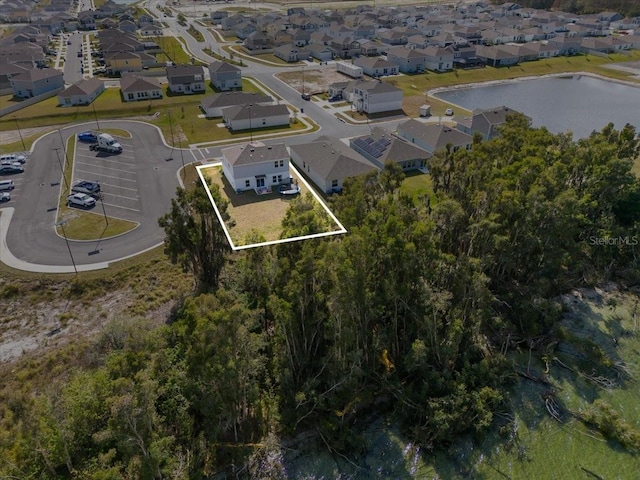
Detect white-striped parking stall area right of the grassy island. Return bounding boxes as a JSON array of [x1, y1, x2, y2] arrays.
[[73, 138, 141, 217]]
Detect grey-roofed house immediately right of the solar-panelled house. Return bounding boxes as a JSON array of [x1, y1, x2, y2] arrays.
[[398, 119, 473, 153]]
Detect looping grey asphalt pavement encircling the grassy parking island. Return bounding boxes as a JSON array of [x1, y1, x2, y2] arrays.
[[3, 120, 182, 271]]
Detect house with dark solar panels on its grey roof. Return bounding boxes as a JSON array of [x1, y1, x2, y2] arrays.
[[349, 127, 431, 171]]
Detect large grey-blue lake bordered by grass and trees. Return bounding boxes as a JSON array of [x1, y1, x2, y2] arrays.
[[434, 75, 640, 138]]
